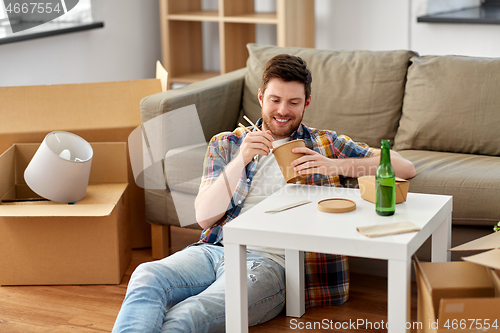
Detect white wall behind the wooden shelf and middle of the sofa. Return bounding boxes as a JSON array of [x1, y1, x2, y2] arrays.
[[202, 0, 411, 70]]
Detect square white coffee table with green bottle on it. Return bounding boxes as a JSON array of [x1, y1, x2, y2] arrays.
[[224, 184, 452, 333]]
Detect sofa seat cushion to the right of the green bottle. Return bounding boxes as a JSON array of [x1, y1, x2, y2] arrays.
[[398, 150, 500, 226]]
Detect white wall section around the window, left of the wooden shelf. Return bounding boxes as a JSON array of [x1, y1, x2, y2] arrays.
[[0, 0, 161, 86]]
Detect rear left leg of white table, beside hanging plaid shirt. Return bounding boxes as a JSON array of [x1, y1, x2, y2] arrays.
[[285, 250, 306, 318]]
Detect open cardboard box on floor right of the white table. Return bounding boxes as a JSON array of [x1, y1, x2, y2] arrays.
[[415, 232, 500, 333]]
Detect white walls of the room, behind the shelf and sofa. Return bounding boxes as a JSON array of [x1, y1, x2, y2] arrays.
[[0, 0, 500, 86]]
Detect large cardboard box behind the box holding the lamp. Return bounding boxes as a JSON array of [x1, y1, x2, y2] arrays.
[[0, 79, 162, 248]]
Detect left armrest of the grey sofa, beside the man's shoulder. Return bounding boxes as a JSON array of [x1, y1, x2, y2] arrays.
[[141, 68, 246, 229]]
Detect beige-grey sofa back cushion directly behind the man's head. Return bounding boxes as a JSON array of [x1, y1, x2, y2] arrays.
[[243, 44, 415, 147]]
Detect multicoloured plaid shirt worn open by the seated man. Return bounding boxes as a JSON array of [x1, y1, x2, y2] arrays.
[[200, 119, 374, 307]]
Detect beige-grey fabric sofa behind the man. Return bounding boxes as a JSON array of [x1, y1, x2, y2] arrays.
[[141, 44, 500, 266]]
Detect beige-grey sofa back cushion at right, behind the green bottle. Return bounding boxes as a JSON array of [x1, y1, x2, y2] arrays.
[[394, 56, 500, 156]]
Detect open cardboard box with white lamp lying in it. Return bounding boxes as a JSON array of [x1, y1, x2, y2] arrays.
[[0, 143, 131, 285]]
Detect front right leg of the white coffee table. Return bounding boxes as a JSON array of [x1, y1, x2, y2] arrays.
[[387, 258, 411, 333]]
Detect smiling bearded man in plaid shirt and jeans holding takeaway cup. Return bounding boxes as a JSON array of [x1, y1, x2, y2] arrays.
[[113, 54, 415, 332]]
